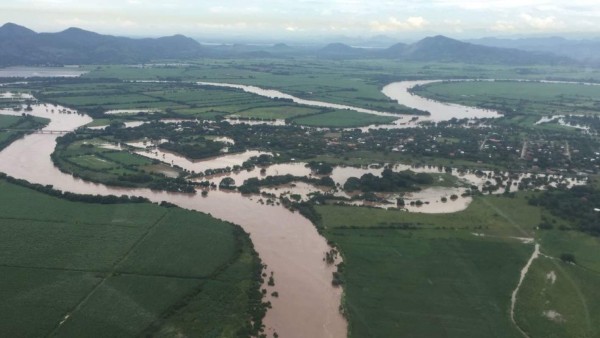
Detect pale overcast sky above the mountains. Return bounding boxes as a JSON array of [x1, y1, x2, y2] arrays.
[[0, 0, 600, 39]]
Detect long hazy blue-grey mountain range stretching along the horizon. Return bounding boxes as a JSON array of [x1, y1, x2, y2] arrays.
[[0, 23, 578, 67]]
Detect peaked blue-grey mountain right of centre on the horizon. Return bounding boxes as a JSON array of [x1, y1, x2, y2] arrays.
[[381, 35, 573, 65]]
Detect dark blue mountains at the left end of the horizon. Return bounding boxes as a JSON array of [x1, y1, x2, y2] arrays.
[[0, 23, 205, 66]]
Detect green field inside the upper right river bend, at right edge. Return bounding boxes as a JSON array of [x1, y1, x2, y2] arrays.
[[418, 81, 600, 116]]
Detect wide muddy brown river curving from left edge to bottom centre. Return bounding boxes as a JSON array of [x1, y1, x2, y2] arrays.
[[0, 105, 347, 337]]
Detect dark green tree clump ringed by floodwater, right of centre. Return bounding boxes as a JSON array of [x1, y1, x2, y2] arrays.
[[344, 168, 434, 192]]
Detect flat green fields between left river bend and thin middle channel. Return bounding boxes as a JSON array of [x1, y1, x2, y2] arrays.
[[22, 77, 408, 127]]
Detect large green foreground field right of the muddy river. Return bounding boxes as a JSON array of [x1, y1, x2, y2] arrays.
[[316, 194, 600, 337]]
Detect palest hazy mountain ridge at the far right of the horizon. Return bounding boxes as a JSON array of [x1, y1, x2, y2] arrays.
[[468, 37, 600, 64]]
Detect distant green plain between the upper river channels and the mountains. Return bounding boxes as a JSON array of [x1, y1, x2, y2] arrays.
[[84, 59, 600, 115]]
